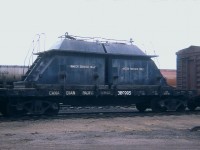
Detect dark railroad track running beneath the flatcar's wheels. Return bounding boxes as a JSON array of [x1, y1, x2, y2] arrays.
[[0, 106, 200, 122]]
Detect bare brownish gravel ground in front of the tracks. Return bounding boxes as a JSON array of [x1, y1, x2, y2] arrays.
[[0, 114, 200, 150]]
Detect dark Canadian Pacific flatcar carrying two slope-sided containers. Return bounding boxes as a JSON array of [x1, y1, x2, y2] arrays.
[[0, 34, 195, 115]]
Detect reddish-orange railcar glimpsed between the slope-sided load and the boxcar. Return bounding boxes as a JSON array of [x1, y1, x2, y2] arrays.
[[160, 69, 176, 87]]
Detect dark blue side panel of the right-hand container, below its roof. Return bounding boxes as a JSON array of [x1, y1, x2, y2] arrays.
[[109, 58, 165, 85]]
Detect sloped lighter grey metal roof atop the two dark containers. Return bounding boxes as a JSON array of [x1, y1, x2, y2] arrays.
[[50, 39, 151, 57]]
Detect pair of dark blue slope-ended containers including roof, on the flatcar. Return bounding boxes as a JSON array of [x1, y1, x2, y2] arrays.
[[22, 39, 166, 87]]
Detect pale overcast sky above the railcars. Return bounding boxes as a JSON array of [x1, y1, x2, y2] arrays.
[[0, 0, 200, 69]]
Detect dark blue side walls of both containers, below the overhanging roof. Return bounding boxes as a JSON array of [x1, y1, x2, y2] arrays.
[[22, 52, 166, 86]]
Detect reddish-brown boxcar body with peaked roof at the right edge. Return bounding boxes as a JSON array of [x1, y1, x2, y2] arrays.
[[176, 46, 200, 94]]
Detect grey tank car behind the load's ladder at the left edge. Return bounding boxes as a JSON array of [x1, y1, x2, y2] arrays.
[[0, 65, 28, 87]]
